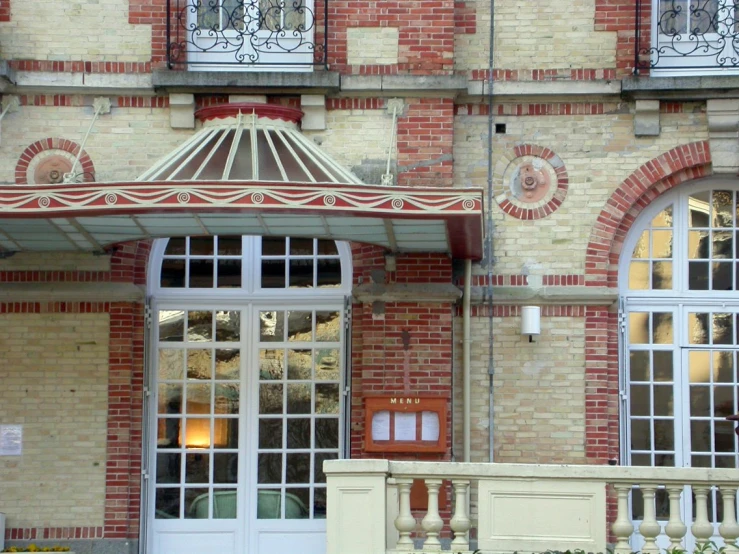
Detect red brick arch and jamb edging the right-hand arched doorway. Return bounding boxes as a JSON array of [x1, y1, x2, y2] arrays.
[[585, 141, 711, 464]]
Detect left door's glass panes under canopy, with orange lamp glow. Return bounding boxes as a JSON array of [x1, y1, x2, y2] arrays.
[[154, 310, 242, 520]]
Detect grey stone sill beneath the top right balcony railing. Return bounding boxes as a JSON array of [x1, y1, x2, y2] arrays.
[[621, 75, 739, 100]]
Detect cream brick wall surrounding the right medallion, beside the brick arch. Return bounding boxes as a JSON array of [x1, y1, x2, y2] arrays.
[[454, 105, 708, 275]]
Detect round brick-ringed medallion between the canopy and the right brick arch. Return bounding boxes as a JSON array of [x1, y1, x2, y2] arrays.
[[493, 144, 569, 219]]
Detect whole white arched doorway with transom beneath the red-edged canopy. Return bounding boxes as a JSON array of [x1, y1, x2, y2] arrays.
[[145, 236, 351, 554]]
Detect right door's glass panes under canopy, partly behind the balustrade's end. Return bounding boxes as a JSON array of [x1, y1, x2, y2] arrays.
[[257, 310, 341, 519]]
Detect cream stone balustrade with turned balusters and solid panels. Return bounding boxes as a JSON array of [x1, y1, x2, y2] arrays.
[[324, 460, 739, 554]]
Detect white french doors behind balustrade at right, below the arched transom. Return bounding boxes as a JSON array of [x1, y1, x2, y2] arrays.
[[624, 302, 739, 550]]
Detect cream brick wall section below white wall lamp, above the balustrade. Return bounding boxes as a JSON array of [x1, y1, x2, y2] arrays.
[[454, 317, 585, 464]]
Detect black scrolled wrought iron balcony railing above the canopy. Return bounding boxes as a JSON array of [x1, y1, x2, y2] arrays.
[[167, 0, 328, 71]]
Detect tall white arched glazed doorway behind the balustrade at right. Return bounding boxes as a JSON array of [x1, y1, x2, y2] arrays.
[[619, 178, 739, 549]]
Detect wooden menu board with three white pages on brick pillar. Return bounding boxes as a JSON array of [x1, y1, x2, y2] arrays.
[[365, 396, 447, 452]]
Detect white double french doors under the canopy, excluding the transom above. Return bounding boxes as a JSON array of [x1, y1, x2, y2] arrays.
[[148, 301, 343, 554]]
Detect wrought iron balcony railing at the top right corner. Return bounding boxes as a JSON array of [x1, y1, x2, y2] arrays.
[[634, 0, 739, 74]]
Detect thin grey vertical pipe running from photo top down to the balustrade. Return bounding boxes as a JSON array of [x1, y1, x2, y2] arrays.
[[485, 0, 495, 463]]
